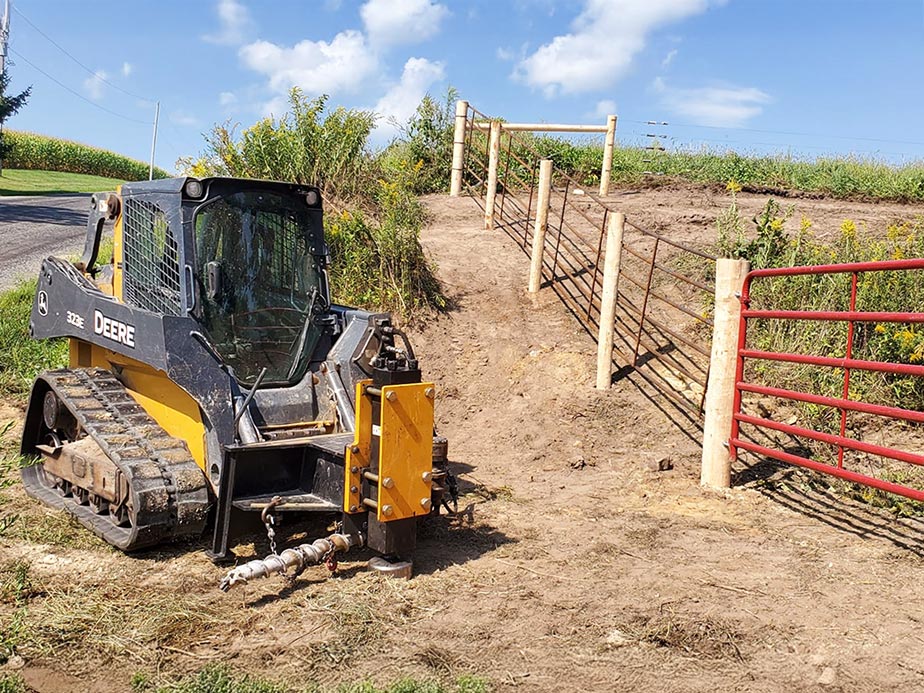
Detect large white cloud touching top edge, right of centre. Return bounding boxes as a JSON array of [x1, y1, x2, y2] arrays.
[[514, 0, 710, 97]]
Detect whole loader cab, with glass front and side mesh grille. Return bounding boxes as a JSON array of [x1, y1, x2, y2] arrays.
[[114, 178, 330, 388]]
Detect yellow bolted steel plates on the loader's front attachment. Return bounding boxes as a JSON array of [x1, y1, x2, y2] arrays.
[[344, 380, 435, 522]]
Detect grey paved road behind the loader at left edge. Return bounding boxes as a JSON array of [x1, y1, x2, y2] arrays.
[[0, 194, 90, 290]]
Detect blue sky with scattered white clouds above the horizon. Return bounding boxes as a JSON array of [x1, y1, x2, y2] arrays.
[[8, 0, 924, 170]]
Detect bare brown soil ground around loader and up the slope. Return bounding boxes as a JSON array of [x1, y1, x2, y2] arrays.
[[0, 187, 924, 692]]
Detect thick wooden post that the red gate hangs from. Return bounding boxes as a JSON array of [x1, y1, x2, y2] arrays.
[[700, 258, 750, 488]]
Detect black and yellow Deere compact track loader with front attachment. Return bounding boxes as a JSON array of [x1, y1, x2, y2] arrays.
[[22, 178, 455, 588]]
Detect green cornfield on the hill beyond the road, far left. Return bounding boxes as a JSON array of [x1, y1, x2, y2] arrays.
[[3, 130, 170, 180]]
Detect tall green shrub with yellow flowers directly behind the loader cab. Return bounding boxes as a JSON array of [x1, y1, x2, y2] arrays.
[[178, 89, 446, 319]]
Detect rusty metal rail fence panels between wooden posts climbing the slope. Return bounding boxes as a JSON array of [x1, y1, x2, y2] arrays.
[[463, 106, 715, 416]]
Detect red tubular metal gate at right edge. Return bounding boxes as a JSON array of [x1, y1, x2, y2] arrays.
[[729, 259, 924, 501]]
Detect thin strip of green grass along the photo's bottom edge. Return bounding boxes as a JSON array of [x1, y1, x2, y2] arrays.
[[131, 664, 491, 693]]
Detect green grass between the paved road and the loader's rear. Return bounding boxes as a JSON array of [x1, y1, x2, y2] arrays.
[[0, 279, 67, 402]]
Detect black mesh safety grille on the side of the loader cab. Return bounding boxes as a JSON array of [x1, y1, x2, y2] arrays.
[[122, 197, 183, 315]]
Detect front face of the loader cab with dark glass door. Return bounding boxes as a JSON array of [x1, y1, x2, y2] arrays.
[[187, 181, 330, 387]]
